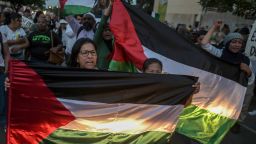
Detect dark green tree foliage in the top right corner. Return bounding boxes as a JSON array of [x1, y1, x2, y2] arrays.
[[199, 0, 256, 19]]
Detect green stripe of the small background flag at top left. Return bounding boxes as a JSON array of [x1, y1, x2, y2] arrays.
[[64, 5, 92, 15]]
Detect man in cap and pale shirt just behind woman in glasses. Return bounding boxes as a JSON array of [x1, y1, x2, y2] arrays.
[[66, 12, 96, 40]]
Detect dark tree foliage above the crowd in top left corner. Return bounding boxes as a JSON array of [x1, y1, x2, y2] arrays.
[[4, 0, 45, 12]]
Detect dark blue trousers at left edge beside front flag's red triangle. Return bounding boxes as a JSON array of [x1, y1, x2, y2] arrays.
[[0, 72, 7, 125]]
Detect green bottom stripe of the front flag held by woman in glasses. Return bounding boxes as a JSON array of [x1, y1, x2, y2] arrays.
[[40, 129, 171, 144]]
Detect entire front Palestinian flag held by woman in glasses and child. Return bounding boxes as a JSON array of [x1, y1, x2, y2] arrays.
[[7, 60, 197, 144]]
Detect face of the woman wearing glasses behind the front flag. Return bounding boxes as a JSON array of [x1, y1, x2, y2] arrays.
[[77, 43, 97, 69]]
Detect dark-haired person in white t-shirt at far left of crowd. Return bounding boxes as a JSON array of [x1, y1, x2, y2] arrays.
[[0, 13, 28, 60]]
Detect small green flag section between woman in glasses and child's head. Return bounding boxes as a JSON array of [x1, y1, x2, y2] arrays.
[[109, 60, 137, 72]]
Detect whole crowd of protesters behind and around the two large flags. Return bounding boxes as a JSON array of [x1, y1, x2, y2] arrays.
[[0, 1, 255, 137]]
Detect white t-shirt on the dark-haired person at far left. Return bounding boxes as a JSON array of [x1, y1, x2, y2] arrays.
[[0, 25, 26, 54]]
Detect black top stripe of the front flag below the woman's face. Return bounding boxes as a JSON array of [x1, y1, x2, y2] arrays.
[[28, 64, 198, 105]]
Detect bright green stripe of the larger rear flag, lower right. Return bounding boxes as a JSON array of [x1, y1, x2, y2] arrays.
[[176, 105, 236, 144]]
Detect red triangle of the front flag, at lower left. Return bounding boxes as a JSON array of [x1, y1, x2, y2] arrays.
[[7, 60, 75, 144]]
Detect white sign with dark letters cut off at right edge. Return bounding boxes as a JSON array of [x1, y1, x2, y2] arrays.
[[245, 21, 256, 61]]
